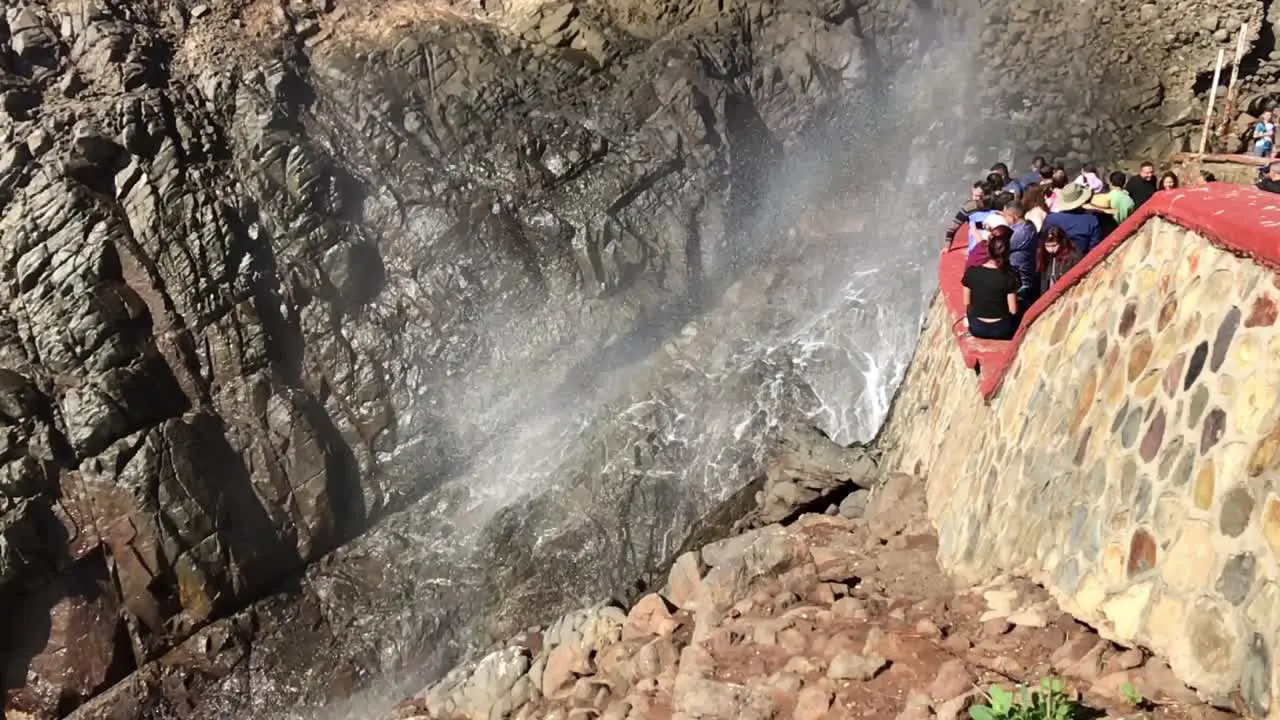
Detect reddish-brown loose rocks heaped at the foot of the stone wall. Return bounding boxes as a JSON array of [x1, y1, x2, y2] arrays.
[[393, 475, 1212, 720]]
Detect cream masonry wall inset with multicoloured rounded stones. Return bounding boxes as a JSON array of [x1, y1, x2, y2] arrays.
[[882, 202, 1280, 716]]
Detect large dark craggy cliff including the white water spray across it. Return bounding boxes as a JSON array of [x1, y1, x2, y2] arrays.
[[0, 0, 989, 717]]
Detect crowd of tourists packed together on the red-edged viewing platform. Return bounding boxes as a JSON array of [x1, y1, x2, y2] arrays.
[[946, 154, 1280, 340]]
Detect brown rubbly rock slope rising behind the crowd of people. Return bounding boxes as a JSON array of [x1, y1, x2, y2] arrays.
[[980, 0, 1280, 161]]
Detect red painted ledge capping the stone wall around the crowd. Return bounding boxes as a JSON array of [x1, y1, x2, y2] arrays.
[[938, 183, 1280, 401]]
